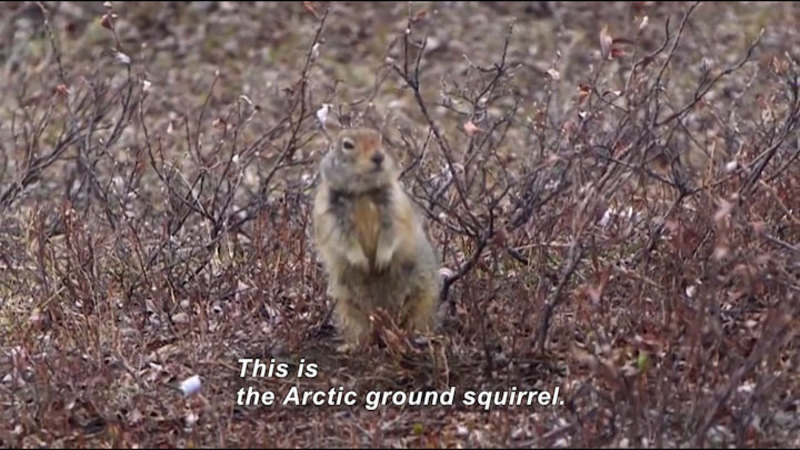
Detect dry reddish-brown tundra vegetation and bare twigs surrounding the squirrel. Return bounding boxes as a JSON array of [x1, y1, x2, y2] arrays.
[[0, 2, 800, 447]]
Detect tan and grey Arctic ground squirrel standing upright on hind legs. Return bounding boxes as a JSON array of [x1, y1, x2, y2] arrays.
[[313, 128, 442, 348]]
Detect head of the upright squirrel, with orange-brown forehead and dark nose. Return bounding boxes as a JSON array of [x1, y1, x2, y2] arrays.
[[323, 128, 397, 193]]
